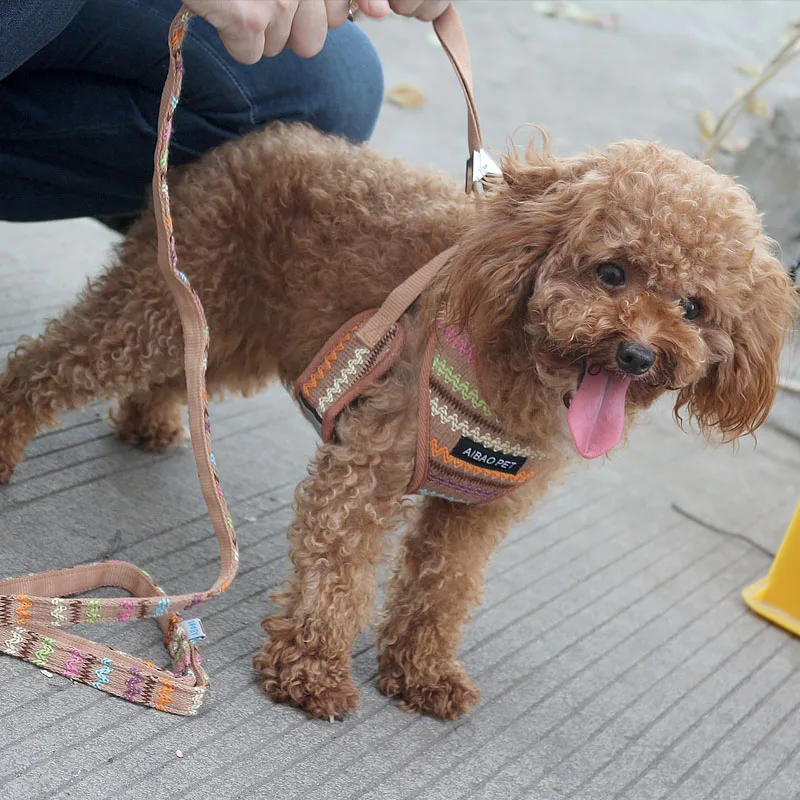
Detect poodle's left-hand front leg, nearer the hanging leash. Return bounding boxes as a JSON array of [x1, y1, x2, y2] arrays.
[[253, 444, 408, 719]]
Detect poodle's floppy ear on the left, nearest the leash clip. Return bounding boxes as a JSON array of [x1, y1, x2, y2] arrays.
[[447, 147, 602, 341]]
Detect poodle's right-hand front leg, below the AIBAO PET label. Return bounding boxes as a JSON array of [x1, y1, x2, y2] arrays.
[[378, 496, 526, 720]]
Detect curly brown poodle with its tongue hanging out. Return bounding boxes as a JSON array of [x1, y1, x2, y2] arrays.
[[0, 126, 795, 719]]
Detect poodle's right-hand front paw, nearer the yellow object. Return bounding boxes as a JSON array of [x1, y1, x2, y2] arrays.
[[378, 663, 481, 721]]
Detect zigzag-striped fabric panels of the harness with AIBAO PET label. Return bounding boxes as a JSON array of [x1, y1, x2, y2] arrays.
[[295, 298, 543, 503]]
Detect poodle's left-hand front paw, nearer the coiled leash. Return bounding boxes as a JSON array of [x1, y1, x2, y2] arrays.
[[253, 639, 359, 720]]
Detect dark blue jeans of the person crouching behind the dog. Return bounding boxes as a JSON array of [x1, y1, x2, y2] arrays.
[[0, 0, 383, 221]]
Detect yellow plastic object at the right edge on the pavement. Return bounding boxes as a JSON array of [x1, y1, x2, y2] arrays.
[[742, 504, 800, 636]]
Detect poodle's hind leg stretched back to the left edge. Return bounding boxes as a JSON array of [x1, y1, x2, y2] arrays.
[[0, 269, 183, 483]]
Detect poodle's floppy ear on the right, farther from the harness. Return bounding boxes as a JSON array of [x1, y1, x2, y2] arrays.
[[675, 243, 797, 441]]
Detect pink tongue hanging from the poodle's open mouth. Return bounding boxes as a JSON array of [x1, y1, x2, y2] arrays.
[[567, 369, 631, 458]]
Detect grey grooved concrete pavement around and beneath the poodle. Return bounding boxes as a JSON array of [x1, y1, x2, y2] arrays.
[[0, 0, 800, 800]]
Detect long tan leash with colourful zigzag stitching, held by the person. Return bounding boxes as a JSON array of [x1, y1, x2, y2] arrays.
[[0, 0, 499, 715]]
